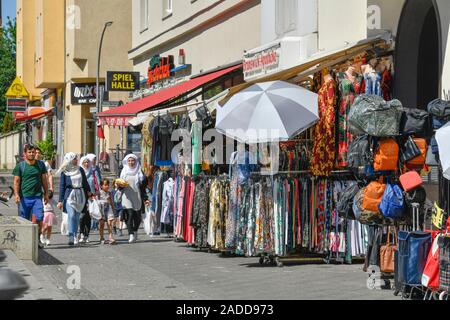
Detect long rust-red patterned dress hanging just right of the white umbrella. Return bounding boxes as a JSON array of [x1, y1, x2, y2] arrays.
[[311, 79, 336, 177]]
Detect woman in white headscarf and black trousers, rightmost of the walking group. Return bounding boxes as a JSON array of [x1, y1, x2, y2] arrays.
[[119, 154, 150, 243]]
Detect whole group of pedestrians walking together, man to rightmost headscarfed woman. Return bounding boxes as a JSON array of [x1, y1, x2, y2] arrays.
[[13, 145, 150, 246]]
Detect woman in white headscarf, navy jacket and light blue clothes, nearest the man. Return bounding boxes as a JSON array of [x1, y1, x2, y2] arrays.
[[58, 152, 91, 246]]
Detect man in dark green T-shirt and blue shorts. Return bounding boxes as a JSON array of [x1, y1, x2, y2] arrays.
[[13, 144, 49, 244]]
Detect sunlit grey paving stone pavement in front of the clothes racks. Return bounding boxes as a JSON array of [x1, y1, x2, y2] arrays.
[[0, 202, 399, 300]]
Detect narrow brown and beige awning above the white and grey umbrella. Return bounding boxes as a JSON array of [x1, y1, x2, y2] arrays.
[[219, 32, 391, 106]]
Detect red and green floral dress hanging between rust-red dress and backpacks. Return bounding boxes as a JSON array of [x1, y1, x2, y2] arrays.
[[337, 73, 362, 168]]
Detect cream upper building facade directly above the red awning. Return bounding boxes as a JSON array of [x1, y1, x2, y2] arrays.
[[128, 0, 261, 80]]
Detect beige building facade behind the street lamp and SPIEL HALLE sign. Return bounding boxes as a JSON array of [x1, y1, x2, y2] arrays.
[[61, 0, 133, 158]]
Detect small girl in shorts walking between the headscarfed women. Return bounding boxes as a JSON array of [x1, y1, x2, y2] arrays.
[[99, 179, 116, 244]]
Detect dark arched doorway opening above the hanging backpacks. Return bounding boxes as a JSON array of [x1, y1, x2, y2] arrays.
[[394, 0, 442, 109]]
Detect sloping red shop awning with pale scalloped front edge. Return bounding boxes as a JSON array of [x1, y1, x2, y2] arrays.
[[99, 64, 242, 126]]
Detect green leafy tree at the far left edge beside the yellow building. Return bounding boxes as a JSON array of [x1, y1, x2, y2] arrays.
[[0, 17, 16, 131]]
